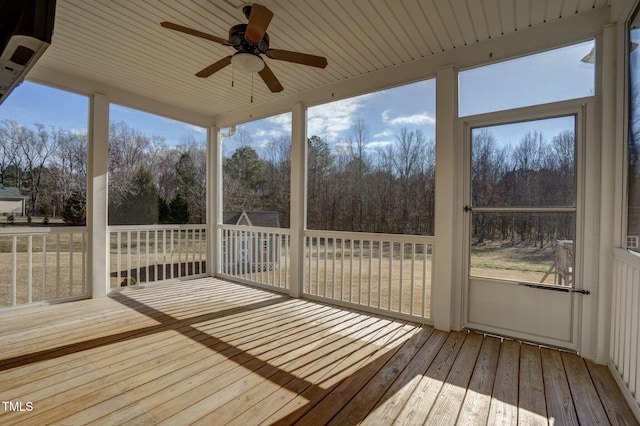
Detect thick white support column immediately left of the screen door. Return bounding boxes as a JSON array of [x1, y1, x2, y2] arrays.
[[431, 67, 462, 331]]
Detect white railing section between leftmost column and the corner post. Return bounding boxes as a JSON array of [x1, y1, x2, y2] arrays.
[[109, 225, 207, 288]]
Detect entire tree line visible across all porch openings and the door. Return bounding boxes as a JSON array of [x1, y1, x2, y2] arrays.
[[0, 116, 576, 244]]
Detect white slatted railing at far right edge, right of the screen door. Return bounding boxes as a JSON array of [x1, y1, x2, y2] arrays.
[[609, 249, 640, 415]]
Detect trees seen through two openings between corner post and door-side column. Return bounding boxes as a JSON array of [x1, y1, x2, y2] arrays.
[[223, 120, 435, 235]]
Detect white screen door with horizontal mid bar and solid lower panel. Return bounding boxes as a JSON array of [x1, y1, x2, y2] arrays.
[[465, 113, 579, 350]]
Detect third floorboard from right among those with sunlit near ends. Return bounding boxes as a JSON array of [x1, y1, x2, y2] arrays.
[[457, 337, 501, 425]]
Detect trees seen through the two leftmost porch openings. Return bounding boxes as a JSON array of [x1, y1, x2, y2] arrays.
[[0, 120, 206, 225]]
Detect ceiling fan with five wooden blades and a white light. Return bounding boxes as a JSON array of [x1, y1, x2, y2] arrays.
[[160, 3, 327, 93]]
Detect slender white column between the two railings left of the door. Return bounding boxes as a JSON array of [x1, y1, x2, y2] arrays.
[[289, 103, 307, 297]]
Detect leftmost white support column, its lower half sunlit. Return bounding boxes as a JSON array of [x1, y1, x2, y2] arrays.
[[87, 94, 109, 298]]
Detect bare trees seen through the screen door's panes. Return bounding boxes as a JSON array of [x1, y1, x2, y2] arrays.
[[471, 128, 576, 247]]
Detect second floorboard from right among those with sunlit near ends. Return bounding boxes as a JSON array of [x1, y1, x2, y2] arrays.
[[488, 340, 520, 425]]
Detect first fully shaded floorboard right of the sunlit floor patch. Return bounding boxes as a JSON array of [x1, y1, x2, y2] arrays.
[[540, 348, 578, 425]]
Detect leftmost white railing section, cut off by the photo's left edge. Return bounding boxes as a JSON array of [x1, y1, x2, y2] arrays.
[[0, 227, 89, 307]]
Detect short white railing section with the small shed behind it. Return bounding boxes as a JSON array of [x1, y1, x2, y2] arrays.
[[218, 225, 291, 291]]
